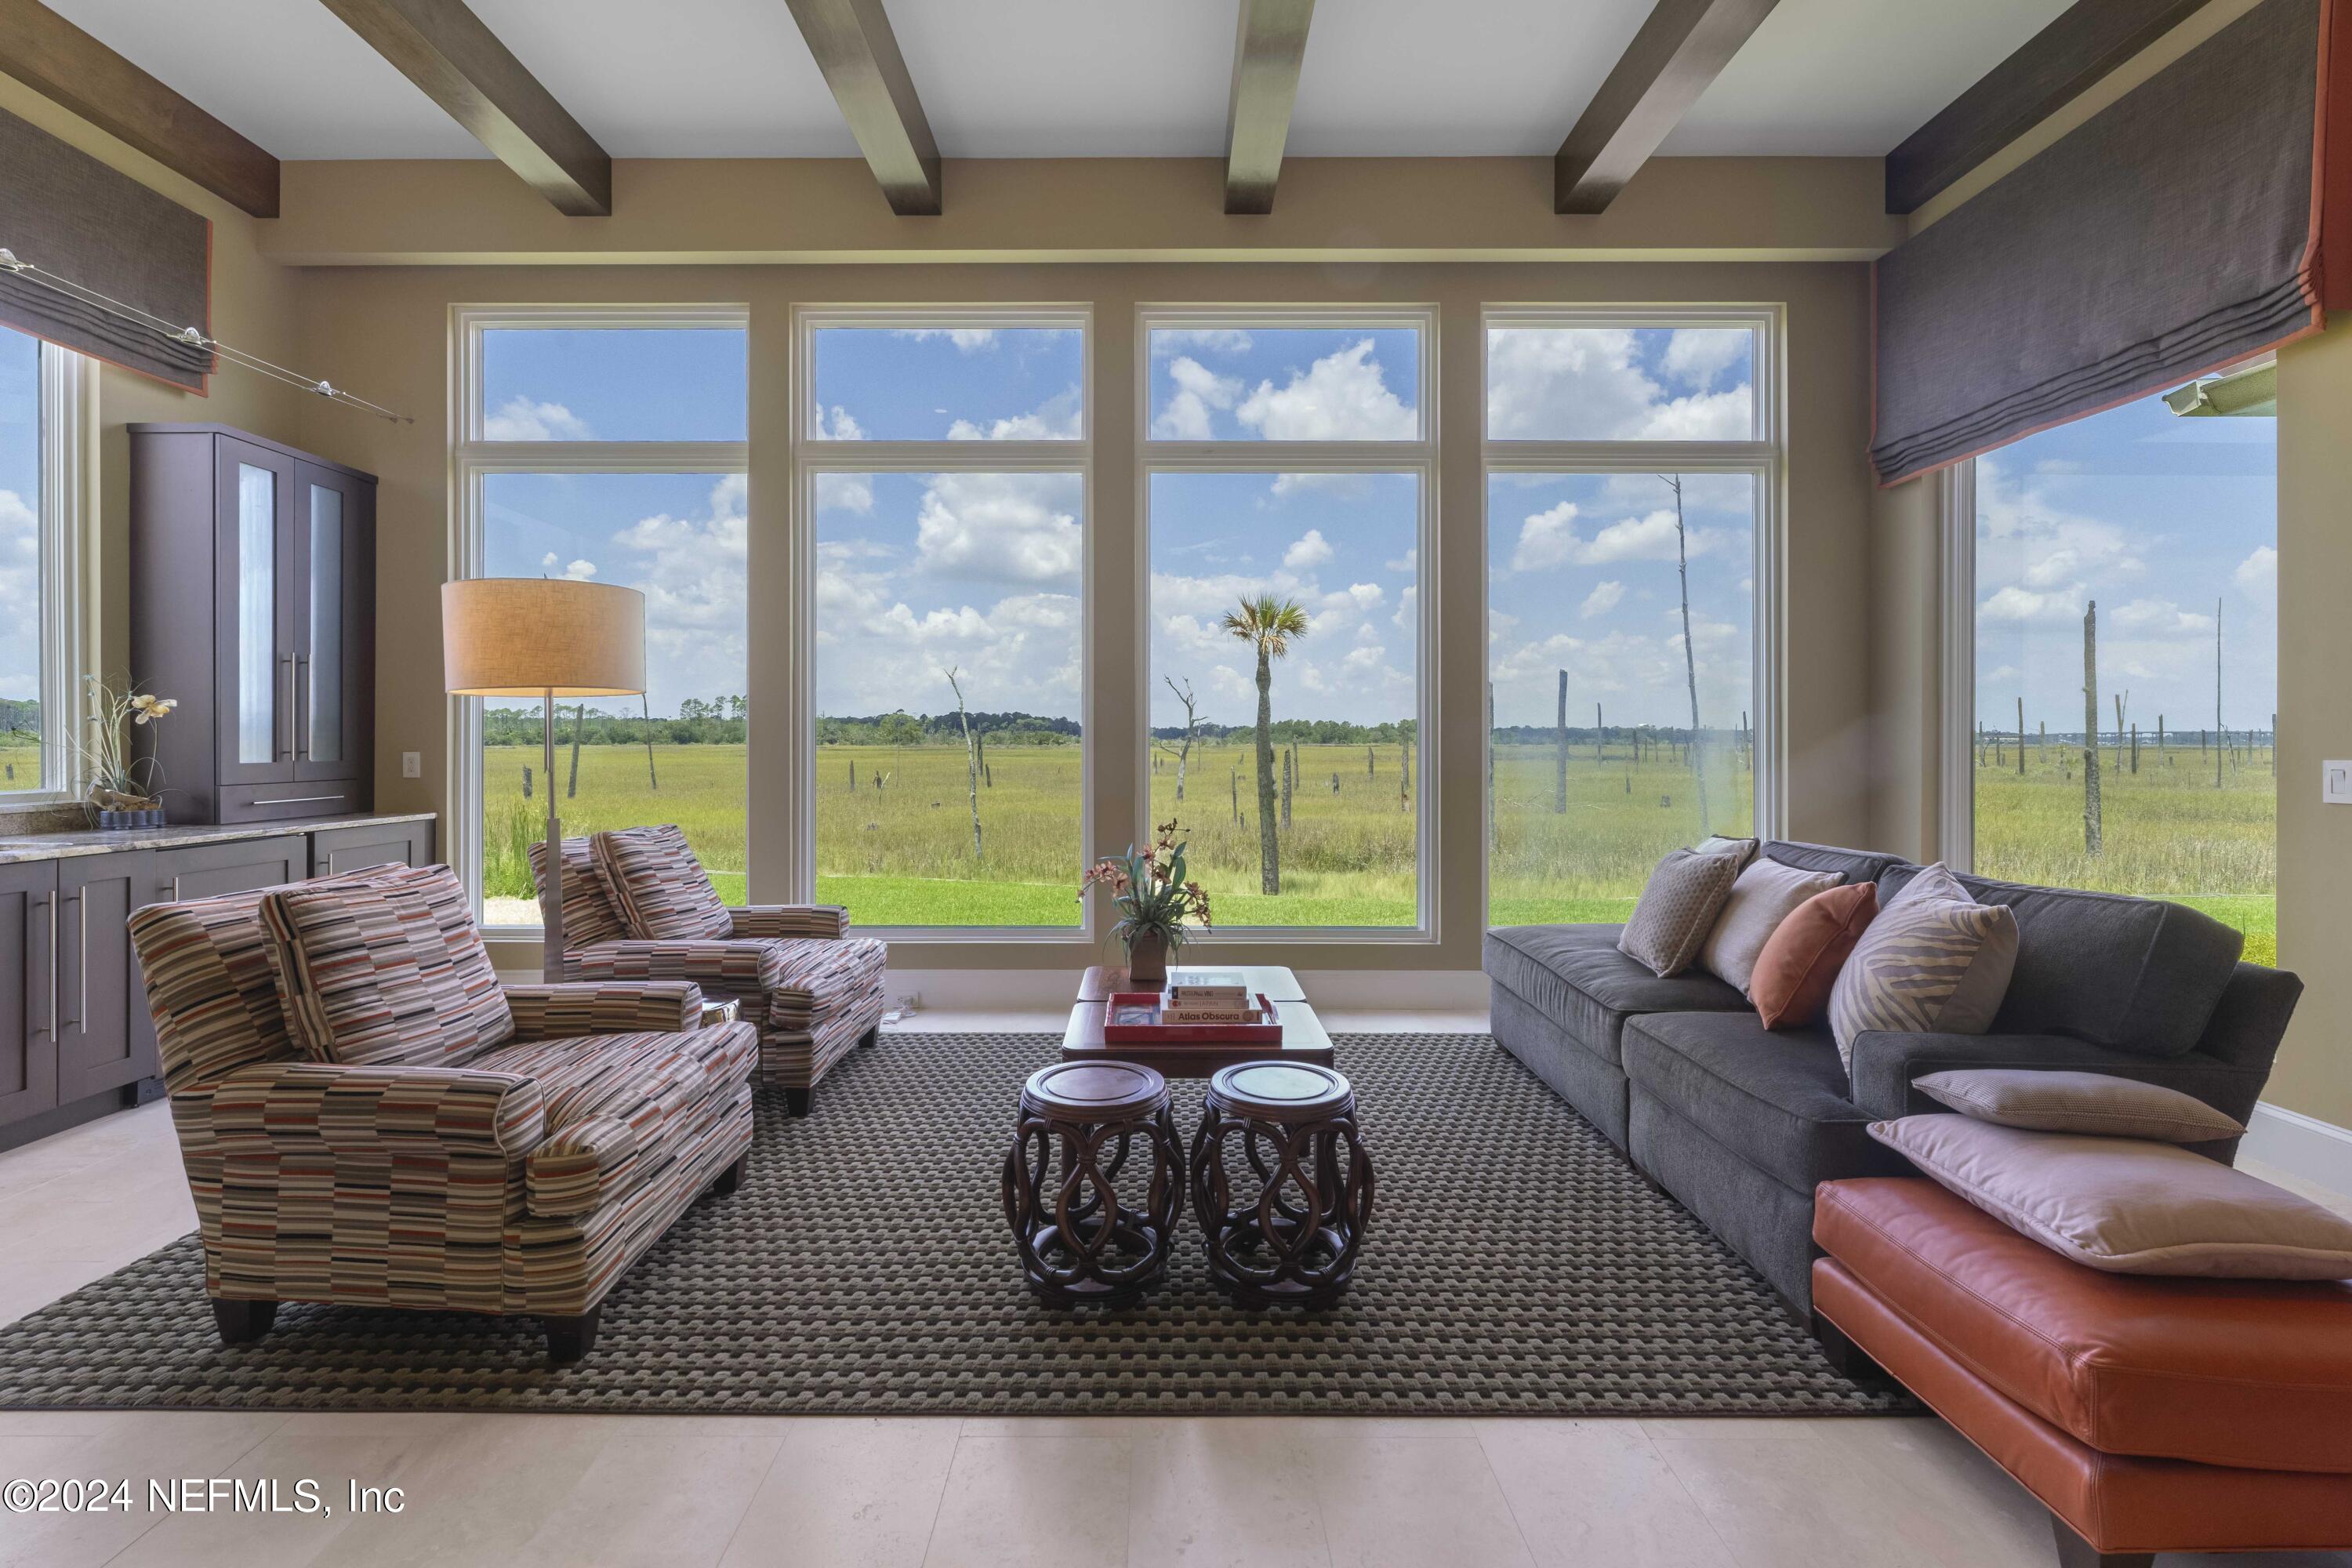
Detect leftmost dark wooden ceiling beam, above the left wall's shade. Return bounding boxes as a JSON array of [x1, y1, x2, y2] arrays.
[[0, 0, 278, 219]]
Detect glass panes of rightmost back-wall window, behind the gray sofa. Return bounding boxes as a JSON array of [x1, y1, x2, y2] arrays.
[[1486, 310, 1778, 924]]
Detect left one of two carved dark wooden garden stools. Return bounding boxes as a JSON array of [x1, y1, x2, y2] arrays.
[[1004, 1062, 1183, 1307]]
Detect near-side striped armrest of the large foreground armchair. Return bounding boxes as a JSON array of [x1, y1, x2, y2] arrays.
[[207, 1060, 548, 1159]]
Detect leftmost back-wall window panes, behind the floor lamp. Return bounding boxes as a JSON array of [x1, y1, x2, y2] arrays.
[[454, 310, 753, 926]]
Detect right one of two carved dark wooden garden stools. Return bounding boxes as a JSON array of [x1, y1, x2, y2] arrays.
[[1192, 1062, 1371, 1307]]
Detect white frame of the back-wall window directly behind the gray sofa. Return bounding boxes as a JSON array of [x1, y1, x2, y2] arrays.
[[1477, 303, 1788, 909]]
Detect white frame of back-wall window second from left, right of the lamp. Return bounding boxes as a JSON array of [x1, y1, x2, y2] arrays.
[[786, 303, 1096, 947]]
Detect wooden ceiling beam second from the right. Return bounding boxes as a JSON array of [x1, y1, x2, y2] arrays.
[[1552, 0, 1778, 214]]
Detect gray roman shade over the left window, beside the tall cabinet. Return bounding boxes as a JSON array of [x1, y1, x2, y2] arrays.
[[0, 111, 212, 393]]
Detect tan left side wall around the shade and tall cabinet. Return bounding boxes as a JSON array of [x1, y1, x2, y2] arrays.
[[0, 78, 303, 822]]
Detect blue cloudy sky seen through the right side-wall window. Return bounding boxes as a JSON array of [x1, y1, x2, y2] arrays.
[[1976, 397, 2279, 734]]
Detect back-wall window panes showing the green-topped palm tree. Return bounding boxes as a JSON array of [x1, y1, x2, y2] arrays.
[[1141, 310, 1435, 933]]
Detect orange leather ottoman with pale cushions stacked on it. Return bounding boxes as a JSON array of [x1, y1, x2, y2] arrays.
[[1813, 1178, 2352, 1566]]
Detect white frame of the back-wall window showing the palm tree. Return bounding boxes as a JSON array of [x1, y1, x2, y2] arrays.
[[1134, 303, 1444, 949]]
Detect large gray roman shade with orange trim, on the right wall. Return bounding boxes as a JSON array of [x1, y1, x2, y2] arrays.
[[1870, 0, 2352, 485]]
